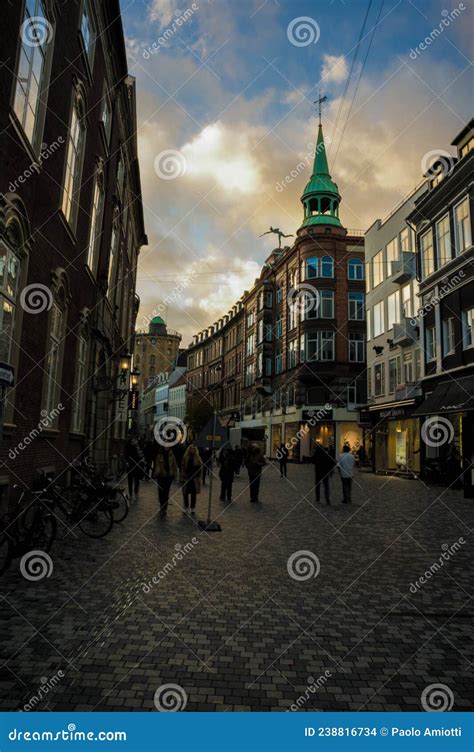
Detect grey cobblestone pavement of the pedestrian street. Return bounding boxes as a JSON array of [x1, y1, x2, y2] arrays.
[[0, 464, 474, 711]]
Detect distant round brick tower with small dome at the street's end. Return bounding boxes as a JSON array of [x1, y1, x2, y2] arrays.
[[133, 316, 181, 387]]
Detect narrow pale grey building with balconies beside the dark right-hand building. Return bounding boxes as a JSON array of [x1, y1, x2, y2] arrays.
[[365, 181, 426, 475]]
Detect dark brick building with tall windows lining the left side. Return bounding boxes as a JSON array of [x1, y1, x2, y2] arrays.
[[0, 0, 146, 496]]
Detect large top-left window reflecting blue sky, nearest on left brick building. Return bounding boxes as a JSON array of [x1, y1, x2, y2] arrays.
[[13, 0, 53, 151]]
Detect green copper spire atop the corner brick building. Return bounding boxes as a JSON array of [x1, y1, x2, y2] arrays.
[[301, 123, 342, 227]]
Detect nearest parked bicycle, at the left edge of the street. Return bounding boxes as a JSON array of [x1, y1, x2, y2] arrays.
[[0, 485, 57, 574]]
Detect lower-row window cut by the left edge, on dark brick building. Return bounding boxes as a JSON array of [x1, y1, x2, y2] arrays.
[[0, 244, 20, 363]]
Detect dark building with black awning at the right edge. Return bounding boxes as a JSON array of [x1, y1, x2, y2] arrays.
[[407, 120, 474, 497]]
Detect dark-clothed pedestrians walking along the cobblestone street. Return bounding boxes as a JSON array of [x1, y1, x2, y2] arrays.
[[125, 437, 356, 514]]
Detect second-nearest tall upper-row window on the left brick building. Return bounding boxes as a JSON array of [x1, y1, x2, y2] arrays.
[[61, 93, 86, 229]]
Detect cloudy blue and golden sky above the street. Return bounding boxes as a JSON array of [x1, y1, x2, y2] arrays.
[[121, 0, 473, 344]]
